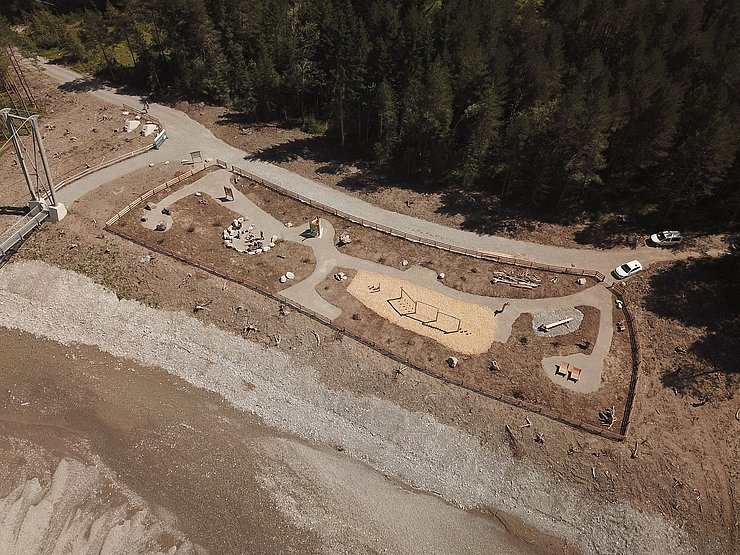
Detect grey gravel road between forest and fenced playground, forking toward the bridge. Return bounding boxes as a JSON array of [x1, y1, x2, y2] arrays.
[[34, 58, 698, 283]]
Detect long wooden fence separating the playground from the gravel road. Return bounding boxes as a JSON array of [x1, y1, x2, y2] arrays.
[[231, 166, 605, 282]]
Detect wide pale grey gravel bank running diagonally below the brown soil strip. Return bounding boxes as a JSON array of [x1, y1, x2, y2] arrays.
[[0, 262, 694, 554]]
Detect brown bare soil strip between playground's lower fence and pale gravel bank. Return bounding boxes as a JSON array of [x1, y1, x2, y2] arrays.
[[19, 172, 740, 554]]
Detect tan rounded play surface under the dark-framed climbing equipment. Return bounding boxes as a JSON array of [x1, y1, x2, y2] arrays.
[[347, 271, 496, 355]]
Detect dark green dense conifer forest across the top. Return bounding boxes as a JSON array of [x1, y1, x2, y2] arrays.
[[5, 0, 740, 229]]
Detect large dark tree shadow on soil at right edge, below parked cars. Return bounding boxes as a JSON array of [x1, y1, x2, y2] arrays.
[[645, 254, 740, 399]]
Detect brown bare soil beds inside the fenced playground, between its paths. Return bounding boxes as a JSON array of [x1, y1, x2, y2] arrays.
[[101, 166, 631, 434]]
